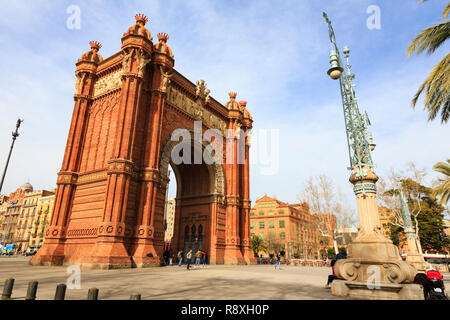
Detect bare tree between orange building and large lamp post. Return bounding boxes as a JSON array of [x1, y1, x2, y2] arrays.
[[297, 174, 356, 253]]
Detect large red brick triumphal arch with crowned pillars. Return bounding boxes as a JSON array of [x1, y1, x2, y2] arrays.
[[31, 14, 254, 268]]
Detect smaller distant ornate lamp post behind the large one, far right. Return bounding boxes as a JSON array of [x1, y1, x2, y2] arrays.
[[398, 184, 428, 271]]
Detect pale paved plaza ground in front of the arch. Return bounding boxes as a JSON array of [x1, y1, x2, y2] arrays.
[[0, 256, 339, 300]]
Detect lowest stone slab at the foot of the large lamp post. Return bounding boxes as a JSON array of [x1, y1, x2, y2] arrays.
[[331, 280, 424, 300]]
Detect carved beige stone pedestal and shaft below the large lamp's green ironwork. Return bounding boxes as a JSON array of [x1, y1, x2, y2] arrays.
[[332, 166, 423, 299]]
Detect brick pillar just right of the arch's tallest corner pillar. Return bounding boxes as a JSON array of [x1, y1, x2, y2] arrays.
[[133, 33, 175, 267]]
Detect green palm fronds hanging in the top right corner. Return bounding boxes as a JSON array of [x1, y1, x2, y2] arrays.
[[406, 0, 450, 123]]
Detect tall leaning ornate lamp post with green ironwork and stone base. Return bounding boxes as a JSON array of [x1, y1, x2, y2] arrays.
[[323, 13, 423, 299]]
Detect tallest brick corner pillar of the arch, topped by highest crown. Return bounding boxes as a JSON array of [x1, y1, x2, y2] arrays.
[[83, 26, 153, 269]]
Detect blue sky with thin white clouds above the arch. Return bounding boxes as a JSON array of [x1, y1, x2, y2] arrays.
[[0, 0, 450, 215]]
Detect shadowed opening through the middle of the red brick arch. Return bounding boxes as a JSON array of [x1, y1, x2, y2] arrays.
[[160, 140, 224, 262]]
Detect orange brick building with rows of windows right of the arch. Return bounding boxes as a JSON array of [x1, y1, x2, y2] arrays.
[[250, 195, 320, 259]]
